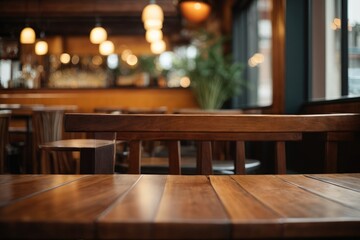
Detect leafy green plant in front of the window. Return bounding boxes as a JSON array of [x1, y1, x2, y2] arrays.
[[188, 34, 244, 109]]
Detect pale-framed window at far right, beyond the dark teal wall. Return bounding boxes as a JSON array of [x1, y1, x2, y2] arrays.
[[310, 0, 360, 100]]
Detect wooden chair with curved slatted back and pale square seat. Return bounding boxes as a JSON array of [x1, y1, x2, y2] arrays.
[[33, 106, 116, 174]]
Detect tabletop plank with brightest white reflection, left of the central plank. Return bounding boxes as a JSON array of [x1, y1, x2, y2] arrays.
[[97, 175, 167, 239]]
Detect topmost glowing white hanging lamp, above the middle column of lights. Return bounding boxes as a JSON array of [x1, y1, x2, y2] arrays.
[[141, 3, 164, 30]]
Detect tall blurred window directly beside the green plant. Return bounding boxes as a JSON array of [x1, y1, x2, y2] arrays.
[[233, 0, 273, 107]]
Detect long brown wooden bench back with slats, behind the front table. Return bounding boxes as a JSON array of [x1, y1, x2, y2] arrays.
[[64, 114, 360, 174]]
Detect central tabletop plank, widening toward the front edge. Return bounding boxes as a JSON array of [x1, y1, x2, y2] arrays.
[[154, 175, 230, 239]]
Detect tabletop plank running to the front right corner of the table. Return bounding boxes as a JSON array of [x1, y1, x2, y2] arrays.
[[233, 175, 360, 237]]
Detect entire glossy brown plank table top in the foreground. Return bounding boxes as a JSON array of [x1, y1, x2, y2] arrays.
[[0, 173, 360, 239]]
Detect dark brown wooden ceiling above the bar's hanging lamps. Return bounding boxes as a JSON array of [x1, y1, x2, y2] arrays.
[[0, 0, 182, 38]]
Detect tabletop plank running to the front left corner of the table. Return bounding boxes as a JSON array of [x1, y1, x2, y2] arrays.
[[0, 175, 139, 238]]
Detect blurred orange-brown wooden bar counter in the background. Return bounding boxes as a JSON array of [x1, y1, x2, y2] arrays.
[[0, 88, 198, 112]]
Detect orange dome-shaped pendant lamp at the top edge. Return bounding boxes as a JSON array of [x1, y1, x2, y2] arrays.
[[180, 1, 211, 23]]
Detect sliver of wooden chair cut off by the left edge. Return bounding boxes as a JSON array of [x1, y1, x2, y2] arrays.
[[0, 110, 11, 174]]
